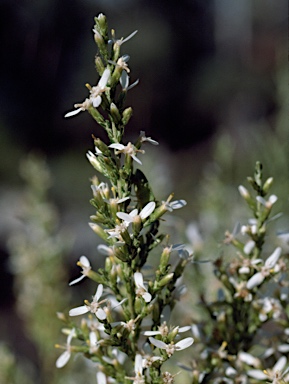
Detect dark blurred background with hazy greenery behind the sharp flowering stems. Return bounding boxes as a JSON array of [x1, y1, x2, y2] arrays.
[[0, 0, 289, 384]]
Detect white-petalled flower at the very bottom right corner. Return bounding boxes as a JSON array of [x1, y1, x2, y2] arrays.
[[247, 356, 289, 384]]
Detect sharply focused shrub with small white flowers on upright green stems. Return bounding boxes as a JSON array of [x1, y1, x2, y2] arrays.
[[56, 14, 289, 384]]
